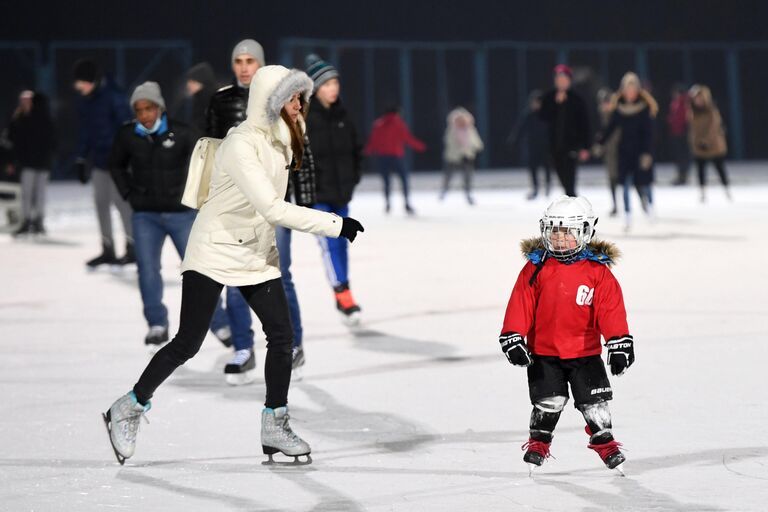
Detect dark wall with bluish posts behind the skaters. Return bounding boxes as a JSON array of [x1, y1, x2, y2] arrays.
[[0, 0, 768, 175]]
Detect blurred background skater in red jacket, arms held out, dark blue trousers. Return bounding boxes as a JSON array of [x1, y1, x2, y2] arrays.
[[364, 107, 427, 215]]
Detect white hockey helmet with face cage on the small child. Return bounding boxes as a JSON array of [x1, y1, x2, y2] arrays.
[[539, 196, 597, 262]]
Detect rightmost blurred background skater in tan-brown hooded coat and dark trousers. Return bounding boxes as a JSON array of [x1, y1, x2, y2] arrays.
[[688, 84, 731, 203]]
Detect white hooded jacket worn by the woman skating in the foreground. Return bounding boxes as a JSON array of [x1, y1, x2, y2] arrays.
[[181, 66, 342, 286]]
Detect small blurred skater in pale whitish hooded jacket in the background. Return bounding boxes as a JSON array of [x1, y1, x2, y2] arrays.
[[440, 107, 483, 204]]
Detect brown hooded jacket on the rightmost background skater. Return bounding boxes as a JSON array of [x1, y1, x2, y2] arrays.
[[688, 85, 728, 158]]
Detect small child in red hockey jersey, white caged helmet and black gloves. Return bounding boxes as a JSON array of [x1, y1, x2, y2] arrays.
[[499, 196, 635, 471]]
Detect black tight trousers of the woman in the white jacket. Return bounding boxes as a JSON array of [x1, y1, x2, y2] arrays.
[[133, 270, 293, 409]]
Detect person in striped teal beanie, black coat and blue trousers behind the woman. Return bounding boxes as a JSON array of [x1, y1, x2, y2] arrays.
[[307, 55, 362, 325]]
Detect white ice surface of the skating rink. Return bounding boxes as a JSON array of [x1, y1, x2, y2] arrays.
[[0, 169, 768, 512]]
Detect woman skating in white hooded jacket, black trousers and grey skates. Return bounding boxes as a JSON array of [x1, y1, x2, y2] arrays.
[[103, 66, 363, 464]]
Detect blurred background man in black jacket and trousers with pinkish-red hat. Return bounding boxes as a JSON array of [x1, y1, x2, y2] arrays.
[[539, 64, 590, 197]]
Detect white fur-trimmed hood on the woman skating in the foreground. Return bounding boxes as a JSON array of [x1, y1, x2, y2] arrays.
[[245, 66, 314, 131]]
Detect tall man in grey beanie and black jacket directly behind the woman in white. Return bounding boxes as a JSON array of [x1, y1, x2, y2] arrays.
[[205, 39, 264, 385]]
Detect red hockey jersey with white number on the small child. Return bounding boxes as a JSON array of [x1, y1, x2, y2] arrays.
[[501, 249, 629, 359]]
